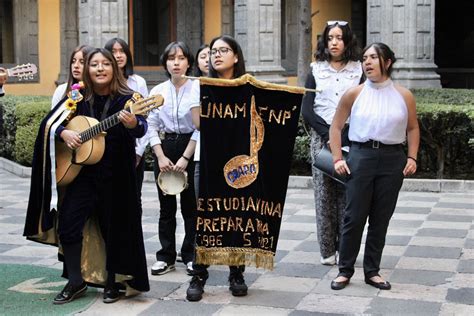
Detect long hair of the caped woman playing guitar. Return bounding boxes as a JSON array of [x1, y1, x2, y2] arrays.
[[83, 48, 133, 101]]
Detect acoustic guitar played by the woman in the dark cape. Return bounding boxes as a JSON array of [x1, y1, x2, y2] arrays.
[[56, 95, 164, 186]]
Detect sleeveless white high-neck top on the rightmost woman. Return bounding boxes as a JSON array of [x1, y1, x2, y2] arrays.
[[349, 79, 408, 145]]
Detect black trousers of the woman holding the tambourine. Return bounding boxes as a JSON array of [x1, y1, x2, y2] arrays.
[[154, 134, 197, 264]]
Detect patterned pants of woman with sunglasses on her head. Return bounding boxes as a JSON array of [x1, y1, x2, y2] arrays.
[[311, 131, 346, 258]]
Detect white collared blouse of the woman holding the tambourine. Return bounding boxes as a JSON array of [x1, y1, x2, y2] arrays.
[[147, 80, 199, 147]]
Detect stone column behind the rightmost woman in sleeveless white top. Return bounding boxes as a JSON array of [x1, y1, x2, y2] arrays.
[[367, 0, 441, 88]]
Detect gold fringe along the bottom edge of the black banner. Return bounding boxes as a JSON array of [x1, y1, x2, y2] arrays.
[[196, 246, 275, 270]]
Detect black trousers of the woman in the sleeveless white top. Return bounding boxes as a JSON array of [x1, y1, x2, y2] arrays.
[[339, 145, 406, 278]]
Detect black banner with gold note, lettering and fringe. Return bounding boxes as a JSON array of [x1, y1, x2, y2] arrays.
[[196, 75, 304, 270]]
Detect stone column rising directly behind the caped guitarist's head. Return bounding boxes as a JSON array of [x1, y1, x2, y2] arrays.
[[77, 0, 128, 47]]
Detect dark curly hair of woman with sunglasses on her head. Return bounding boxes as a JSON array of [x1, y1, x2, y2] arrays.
[[314, 22, 360, 63]]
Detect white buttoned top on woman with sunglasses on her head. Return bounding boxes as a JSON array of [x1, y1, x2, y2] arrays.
[[311, 61, 362, 125]]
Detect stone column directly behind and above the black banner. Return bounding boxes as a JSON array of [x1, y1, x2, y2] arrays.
[[234, 0, 287, 83]]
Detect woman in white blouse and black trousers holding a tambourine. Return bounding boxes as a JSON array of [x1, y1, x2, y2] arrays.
[[147, 42, 199, 275]]
